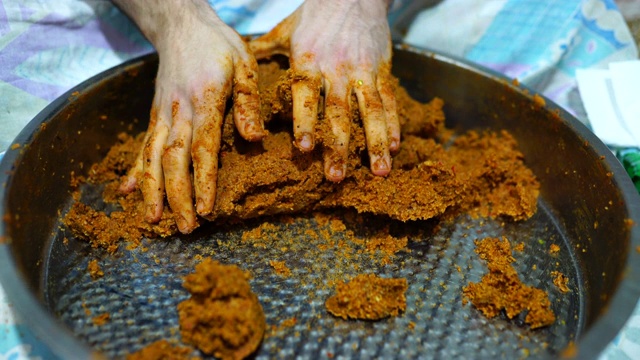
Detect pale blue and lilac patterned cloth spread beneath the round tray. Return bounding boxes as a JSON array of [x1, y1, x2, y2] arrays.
[[0, 0, 640, 360]]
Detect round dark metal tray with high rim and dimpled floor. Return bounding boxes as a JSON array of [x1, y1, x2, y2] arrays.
[[0, 47, 640, 359]]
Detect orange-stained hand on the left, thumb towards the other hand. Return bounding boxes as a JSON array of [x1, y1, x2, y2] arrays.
[[116, 0, 263, 233]]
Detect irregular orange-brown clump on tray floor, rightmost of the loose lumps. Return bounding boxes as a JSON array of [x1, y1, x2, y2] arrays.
[[463, 238, 556, 329]]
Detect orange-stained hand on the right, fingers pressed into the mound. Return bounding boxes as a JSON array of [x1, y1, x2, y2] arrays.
[[250, 0, 400, 181]]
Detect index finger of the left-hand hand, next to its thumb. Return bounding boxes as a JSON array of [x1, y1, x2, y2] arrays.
[[191, 86, 227, 215]]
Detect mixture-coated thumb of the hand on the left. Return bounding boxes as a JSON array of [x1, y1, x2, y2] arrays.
[[233, 52, 264, 141]]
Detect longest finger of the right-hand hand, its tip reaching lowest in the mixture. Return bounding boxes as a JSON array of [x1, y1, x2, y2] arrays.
[[324, 77, 351, 182]]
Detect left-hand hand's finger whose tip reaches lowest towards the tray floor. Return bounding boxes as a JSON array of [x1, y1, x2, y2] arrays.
[[162, 101, 196, 234]]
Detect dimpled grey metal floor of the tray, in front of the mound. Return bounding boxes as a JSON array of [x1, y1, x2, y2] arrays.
[[44, 184, 584, 359]]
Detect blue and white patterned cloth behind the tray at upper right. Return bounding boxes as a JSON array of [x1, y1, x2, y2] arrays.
[[405, 0, 638, 124]]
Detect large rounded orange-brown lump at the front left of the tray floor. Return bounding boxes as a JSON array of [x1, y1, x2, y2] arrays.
[[178, 258, 266, 359]]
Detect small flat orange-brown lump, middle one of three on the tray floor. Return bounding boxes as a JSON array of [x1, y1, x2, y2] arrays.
[[325, 274, 407, 320]]
